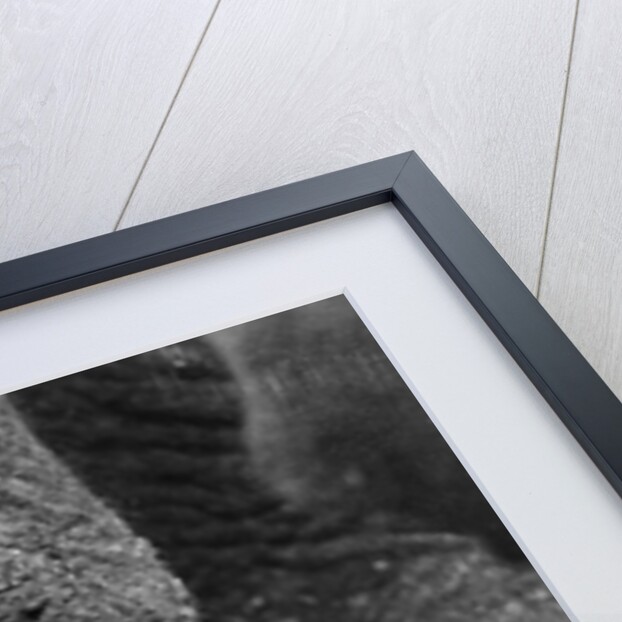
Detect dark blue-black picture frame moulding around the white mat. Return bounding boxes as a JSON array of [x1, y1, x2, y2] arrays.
[[0, 151, 622, 496]]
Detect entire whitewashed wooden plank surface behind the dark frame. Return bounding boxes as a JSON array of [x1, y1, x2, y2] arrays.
[[0, 0, 622, 397]]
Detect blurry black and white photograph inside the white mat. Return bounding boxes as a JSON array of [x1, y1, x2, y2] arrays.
[[0, 296, 568, 622]]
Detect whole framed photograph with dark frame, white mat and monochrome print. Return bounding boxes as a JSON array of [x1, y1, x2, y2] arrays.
[[0, 152, 622, 622]]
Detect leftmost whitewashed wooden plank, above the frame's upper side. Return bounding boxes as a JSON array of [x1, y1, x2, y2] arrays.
[[0, 0, 215, 261]]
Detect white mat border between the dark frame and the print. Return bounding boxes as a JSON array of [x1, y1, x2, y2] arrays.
[[0, 206, 622, 622]]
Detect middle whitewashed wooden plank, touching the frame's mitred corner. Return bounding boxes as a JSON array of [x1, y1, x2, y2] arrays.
[[121, 0, 574, 287]]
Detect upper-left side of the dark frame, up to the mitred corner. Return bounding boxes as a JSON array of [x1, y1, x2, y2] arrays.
[[0, 152, 412, 311]]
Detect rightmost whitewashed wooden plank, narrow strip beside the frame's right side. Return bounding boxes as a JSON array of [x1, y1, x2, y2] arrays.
[[541, 0, 622, 398]]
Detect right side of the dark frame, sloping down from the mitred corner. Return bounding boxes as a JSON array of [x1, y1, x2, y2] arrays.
[[393, 152, 622, 496]]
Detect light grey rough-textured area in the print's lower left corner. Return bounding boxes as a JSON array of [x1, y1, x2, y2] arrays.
[[0, 398, 196, 622]]
